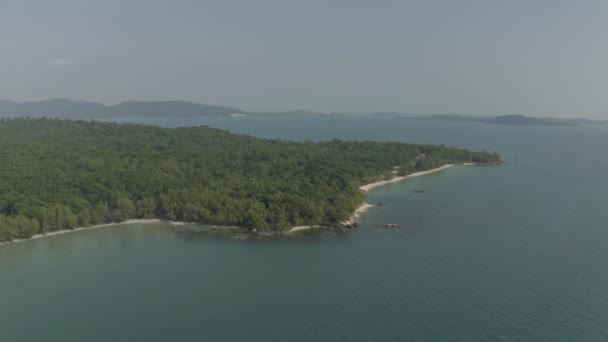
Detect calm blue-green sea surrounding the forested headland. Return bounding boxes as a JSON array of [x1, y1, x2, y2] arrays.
[[0, 118, 608, 342]]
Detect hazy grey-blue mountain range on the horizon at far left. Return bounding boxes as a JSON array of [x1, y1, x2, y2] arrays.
[[0, 99, 332, 120]]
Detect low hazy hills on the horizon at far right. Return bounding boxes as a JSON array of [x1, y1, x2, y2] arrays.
[[400, 114, 608, 126]]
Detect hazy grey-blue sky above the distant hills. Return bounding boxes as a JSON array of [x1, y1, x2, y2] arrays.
[[0, 0, 608, 117]]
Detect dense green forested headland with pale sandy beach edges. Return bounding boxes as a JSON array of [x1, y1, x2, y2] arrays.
[[0, 118, 500, 242]]
